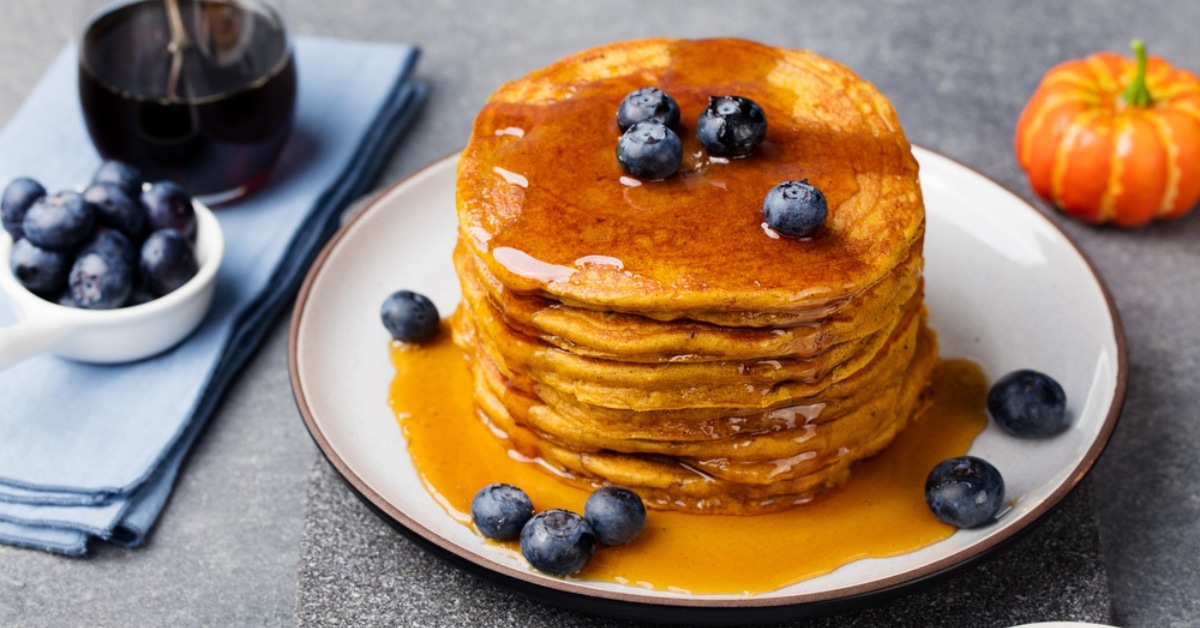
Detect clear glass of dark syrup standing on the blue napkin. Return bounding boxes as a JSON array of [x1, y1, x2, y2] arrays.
[[79, 0, 296, 202]]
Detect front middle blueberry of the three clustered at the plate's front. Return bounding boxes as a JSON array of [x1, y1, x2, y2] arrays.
[[521, 509, 596, 575]]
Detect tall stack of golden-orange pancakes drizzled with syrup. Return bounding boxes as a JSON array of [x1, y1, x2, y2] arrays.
[[454, 40, 937, 514]]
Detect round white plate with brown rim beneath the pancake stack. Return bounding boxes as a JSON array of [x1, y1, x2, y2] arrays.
[[290, 148, 1127, 621]]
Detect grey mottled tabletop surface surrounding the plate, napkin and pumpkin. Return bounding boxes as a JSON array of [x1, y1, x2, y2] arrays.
[[0, 0, 1200, 626]]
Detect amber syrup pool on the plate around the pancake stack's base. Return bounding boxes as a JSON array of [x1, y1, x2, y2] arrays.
[[389, 325, 988, 594]]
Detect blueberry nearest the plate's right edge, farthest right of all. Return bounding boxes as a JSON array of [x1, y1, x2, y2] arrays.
[[988, 369, 1067, 438]]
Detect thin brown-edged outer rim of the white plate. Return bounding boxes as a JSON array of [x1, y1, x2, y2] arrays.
[[288, 144, 1129, 624]]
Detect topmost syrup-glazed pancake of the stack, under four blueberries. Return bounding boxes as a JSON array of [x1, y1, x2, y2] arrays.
[[457, 40, 924, 317]]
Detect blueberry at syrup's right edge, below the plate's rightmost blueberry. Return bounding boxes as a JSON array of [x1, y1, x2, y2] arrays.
[[925, 456, 1004, 527]]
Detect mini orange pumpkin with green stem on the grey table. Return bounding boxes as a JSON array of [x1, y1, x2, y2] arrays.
[[1016, 40, 1200, 227]]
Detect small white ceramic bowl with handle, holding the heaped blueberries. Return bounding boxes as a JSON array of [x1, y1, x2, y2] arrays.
[[0, 202, 224, 369]]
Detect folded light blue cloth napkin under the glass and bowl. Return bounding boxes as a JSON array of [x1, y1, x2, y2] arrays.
[[0, 37, 427, 555]]
